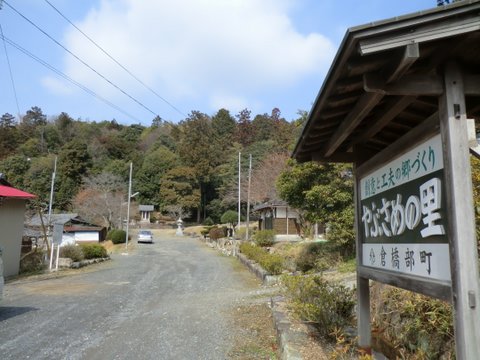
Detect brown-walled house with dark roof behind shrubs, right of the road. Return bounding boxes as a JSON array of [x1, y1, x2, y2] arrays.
[[253, 200, 301, 241]]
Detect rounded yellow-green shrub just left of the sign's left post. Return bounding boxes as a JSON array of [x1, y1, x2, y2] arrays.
[[283, 276, 355, 338]]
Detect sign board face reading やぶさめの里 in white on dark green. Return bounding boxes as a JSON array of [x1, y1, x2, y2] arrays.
[[359, 135, 451, 282]]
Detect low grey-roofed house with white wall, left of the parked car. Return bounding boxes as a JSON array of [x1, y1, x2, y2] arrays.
[[25, 213, 106, 245]]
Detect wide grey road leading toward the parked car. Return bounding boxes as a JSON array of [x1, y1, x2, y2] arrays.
[[0, 237, 259, 360]]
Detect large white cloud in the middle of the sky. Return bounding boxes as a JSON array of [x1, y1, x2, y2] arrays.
[[54, 0, 335, 111]]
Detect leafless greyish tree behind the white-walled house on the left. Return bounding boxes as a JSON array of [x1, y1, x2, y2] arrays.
[[74, 173, 126, 229]]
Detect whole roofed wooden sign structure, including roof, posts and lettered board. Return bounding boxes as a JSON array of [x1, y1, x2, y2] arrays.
[[293, 0, 480, 359]]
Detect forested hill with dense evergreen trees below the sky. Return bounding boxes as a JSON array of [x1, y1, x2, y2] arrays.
[[0, 107, 306, 226]]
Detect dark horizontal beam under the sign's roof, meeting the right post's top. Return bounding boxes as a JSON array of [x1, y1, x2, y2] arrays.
[[364, 74, 443, 96]]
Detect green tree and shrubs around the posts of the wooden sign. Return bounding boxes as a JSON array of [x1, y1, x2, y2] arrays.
[[234, 158, 470, 360]]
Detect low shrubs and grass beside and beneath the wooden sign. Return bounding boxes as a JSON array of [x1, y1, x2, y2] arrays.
[[240, 236, 455, 360]]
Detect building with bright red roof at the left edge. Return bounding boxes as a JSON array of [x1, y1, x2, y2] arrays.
[[0, 178, 35, 277]]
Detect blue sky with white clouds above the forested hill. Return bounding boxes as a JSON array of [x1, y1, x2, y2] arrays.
[[0, 0, 436, 125]]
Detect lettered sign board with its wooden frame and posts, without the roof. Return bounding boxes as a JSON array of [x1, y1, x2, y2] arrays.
[[355, 63, 480, 359]]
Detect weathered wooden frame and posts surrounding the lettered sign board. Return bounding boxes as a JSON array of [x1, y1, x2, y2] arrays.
[[354, 62, 480, 359]]
